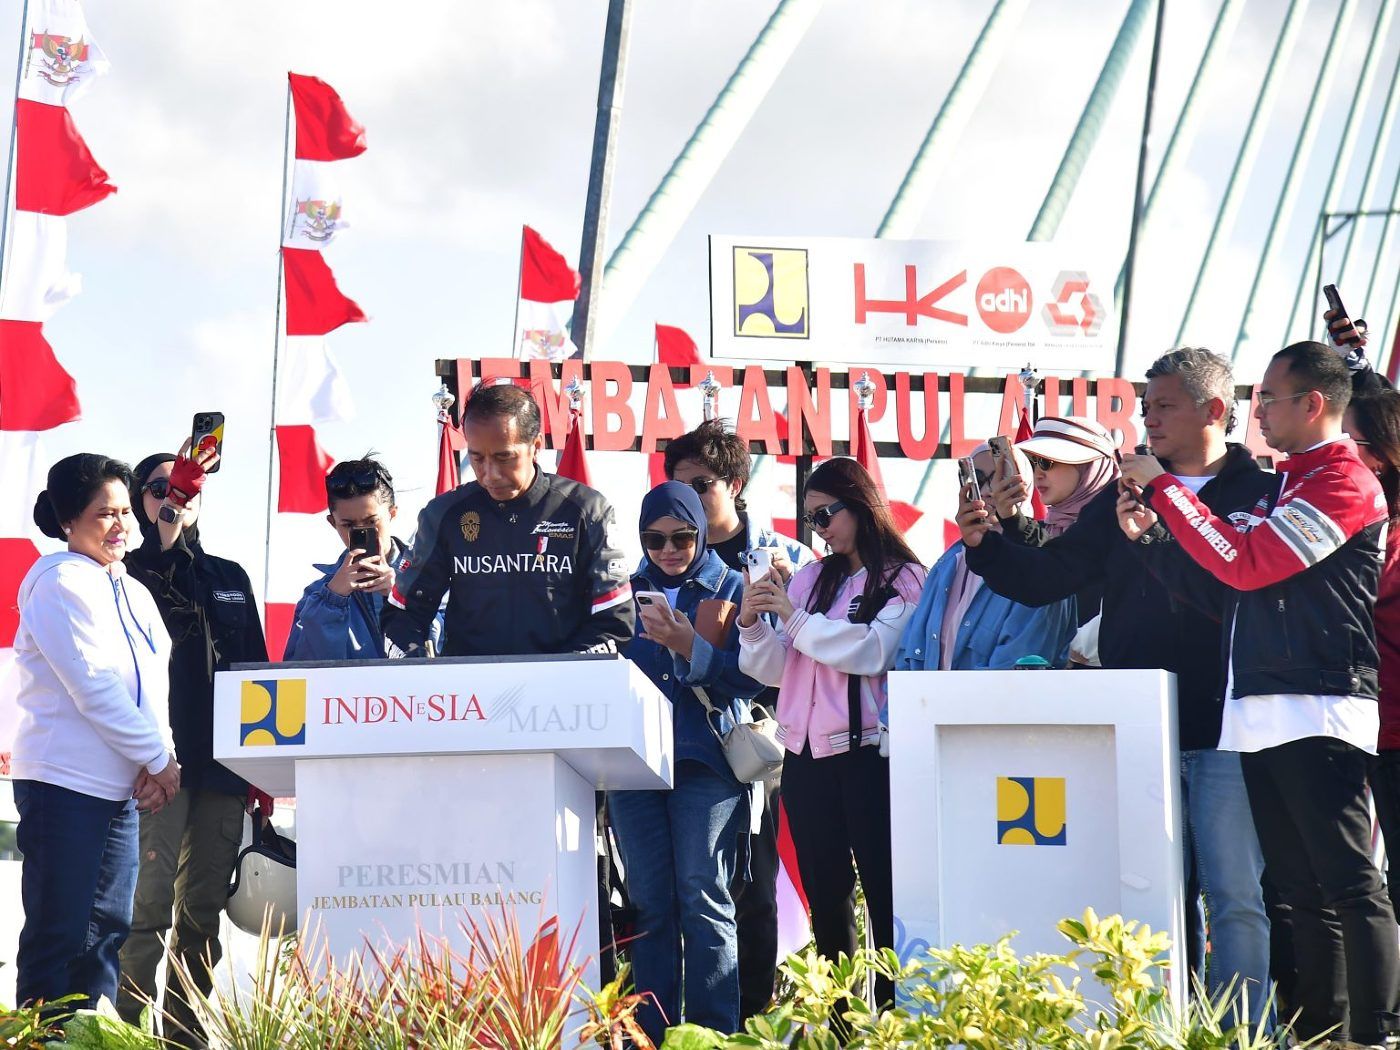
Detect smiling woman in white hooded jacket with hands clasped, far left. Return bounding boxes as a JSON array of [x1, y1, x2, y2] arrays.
[[11, 454, 179, 1005]]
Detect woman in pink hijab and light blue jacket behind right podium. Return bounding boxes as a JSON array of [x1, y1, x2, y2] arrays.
[[895, 442, 1075, 671]]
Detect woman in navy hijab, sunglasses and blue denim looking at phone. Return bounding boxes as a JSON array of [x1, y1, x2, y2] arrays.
[[608, 482, 759, 1046]]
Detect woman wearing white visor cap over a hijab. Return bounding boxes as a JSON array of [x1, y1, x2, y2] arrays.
[[990, 416, 1119, 624]]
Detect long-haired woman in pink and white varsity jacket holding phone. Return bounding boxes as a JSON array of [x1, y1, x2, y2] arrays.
[[739, 459, 925, 1004]]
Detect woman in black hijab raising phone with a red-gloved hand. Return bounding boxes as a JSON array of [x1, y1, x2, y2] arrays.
[[118, 442, 267, 1047]]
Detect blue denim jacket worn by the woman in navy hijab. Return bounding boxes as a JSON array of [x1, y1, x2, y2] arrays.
[[623, 550, 762, 780]]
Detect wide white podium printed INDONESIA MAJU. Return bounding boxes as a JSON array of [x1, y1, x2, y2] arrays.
[[214, 655, 672, 987]]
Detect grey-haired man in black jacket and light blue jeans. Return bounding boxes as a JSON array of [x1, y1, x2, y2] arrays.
[[958, 349, 1274, 1019]]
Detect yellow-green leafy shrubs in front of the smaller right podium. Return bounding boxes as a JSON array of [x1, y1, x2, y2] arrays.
[[662, 910, 1308, 1050]]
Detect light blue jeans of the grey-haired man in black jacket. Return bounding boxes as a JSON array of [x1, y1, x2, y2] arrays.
[[1182, 749, 1270, 1025]]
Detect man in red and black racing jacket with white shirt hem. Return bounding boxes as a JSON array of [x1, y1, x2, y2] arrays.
[[1119, 343, 1400, 1046]]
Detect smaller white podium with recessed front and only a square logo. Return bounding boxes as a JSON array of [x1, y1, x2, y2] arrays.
[[889, 671, 1186, 994]]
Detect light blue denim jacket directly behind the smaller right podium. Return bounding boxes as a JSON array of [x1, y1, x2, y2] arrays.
[[895, 543, 1075, 671]]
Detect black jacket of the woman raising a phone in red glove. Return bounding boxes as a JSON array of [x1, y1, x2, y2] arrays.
[[126, 535, 267, 795]]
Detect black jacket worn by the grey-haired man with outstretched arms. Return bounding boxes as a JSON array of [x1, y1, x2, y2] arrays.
[[966, 444, 1278, 750]]
